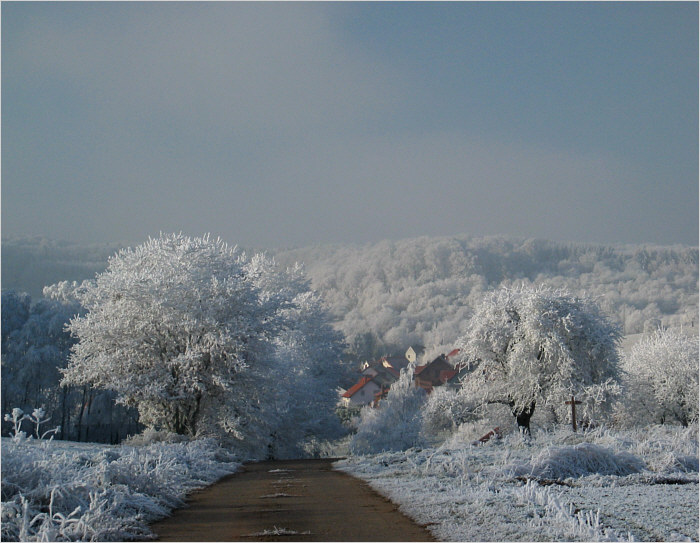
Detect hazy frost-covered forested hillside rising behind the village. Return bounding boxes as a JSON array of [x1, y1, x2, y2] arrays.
[[2, 235, 698, 357]]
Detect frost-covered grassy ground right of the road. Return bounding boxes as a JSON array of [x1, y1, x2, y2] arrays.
[[336, 427, 699, 541]]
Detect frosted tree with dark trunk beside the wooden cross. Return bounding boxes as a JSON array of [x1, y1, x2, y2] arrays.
[[457, 287, 620, 432]]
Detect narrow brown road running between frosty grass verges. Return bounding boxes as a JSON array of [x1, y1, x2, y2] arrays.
[[151, 459, 435, 541]]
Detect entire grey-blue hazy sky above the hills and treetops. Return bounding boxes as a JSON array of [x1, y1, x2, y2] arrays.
[[1, 2, 698, 248]]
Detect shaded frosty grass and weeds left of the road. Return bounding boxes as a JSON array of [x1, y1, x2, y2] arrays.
[[2, 438, 239, 541]]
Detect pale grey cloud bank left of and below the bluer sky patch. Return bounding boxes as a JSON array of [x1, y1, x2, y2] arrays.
[[2, 2, 697, 246]]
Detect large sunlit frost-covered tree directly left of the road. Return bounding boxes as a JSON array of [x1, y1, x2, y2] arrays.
[[63, 235, 275, 435]]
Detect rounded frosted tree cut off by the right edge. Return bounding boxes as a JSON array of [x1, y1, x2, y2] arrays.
[[624, 329, 698, 426]]
